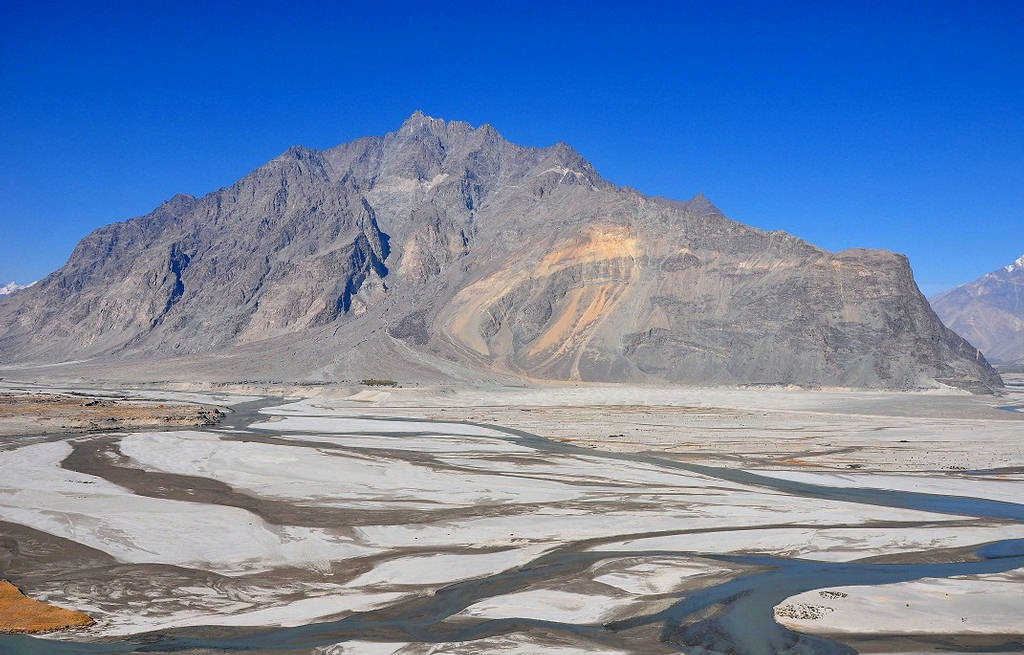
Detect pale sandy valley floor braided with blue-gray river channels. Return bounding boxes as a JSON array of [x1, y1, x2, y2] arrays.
[[0, 378, 1024, 655]]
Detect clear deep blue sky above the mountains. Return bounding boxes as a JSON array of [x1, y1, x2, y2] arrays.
[[0, 0, 1024, 294]]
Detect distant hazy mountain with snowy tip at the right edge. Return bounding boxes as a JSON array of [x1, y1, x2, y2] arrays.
[[932, 255, 1024, 365]]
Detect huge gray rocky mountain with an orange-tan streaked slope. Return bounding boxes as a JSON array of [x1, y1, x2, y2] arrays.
[[0, 113, 1000, 390]]
